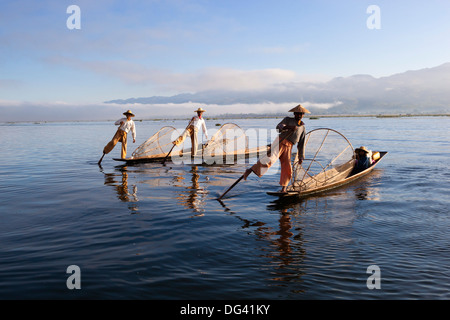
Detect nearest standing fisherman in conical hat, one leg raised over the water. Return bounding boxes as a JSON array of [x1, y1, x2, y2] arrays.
[[244, 104, 310, 192]]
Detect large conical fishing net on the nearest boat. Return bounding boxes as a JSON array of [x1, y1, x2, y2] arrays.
[[291, 129, 354, 193]]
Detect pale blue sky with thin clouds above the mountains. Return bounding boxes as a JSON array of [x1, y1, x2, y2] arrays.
[[0, 0, 450, 120]]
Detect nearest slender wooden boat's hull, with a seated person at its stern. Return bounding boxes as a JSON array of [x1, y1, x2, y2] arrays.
[[267, 151, 387, 198]]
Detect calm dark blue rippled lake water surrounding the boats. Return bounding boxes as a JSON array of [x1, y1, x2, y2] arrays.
[[0, 117, 450, 300]]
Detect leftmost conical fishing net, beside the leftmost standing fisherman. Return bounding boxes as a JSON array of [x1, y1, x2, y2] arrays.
[[132, 126, 180, 159]]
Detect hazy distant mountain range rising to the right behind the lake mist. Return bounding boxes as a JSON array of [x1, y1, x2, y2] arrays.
[[106, 63, 450, 114]]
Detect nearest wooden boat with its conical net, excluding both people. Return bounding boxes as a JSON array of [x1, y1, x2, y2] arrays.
[[267, 129, 387, 198]]
